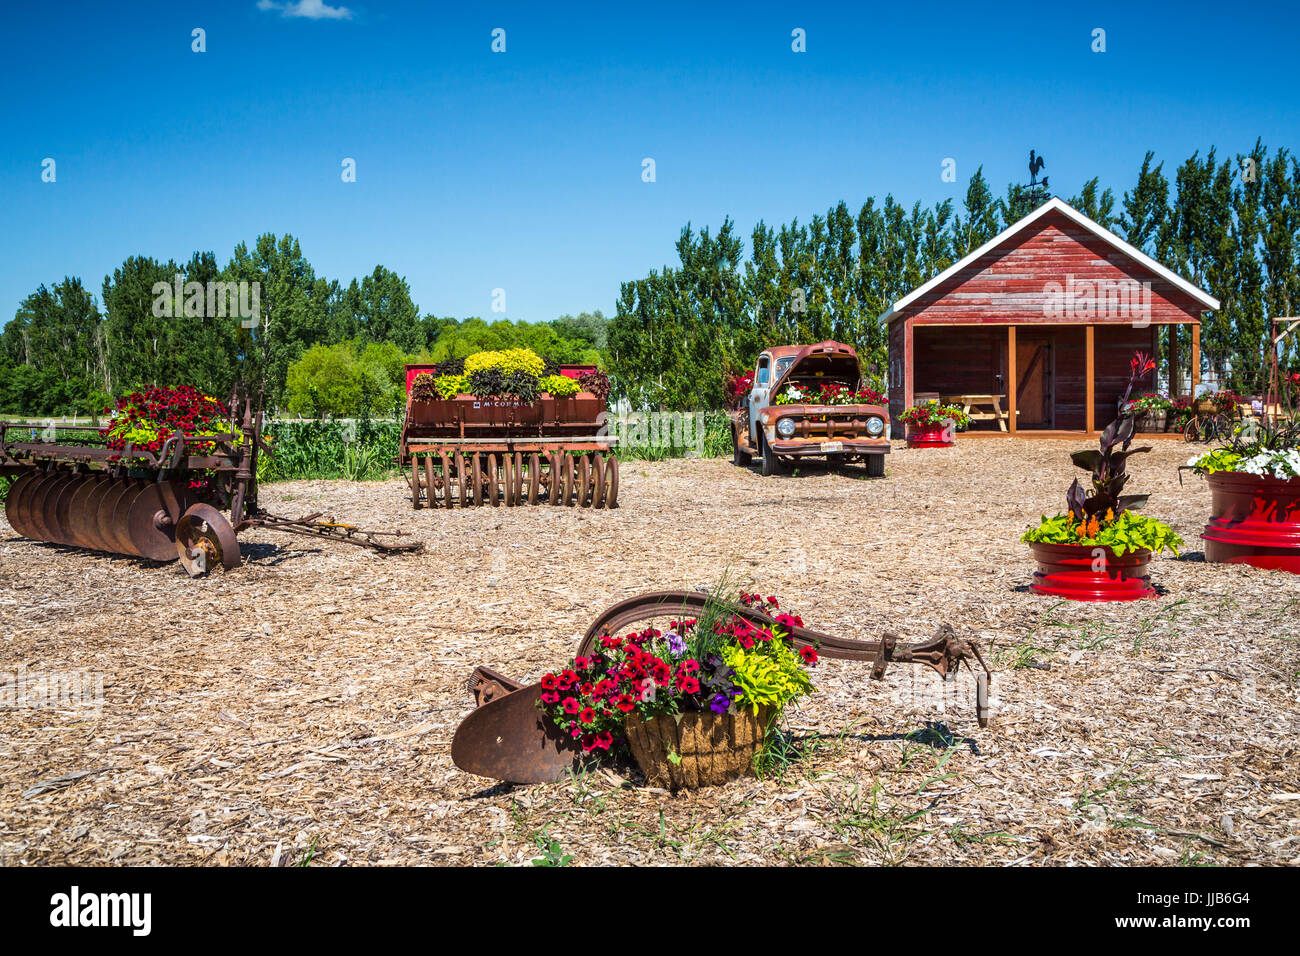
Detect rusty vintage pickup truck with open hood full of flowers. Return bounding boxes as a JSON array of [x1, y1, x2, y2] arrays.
[[731, 341, 889, 477]]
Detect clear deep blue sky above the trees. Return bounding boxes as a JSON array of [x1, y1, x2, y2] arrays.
[[0, 0, 1300, 321]]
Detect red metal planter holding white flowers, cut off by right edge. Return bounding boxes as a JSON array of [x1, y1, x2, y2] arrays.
[[1201, 471, 1300, 574]]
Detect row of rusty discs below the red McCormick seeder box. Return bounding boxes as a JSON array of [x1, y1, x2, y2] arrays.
[[407, 451, 619, 509]]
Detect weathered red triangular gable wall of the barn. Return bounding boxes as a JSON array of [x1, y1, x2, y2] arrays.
[[900, 212, 1201, 325]]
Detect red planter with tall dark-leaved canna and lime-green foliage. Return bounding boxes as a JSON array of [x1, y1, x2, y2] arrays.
[[1021, 352, 1183, 601]]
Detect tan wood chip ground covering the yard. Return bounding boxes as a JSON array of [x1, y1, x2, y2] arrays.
[[0, 440, 1300, 865]]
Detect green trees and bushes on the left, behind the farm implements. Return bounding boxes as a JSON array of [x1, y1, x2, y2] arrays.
[[0, 234, 606, 415]]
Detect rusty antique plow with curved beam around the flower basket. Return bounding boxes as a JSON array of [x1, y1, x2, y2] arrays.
[[451, 591, 993, 783]]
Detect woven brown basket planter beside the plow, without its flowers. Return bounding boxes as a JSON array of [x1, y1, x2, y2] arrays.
[[624, 708, 772, 790]]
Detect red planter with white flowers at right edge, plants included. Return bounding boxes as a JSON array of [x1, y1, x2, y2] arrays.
[[1186, 420, 1300, 574]]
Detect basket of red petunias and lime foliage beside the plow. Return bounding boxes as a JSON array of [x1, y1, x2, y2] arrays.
[[537, 592, 818, 790]]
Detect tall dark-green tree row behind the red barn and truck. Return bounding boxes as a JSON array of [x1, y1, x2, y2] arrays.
[[608, 142, 1300, 410]]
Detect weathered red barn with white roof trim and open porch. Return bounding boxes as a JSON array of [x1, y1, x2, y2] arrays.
[[880, 198, 1219, 433]]
